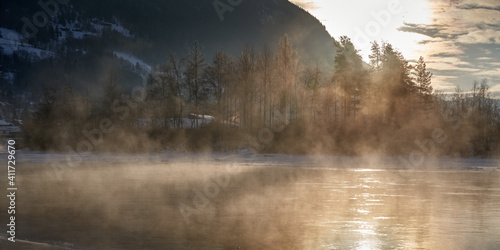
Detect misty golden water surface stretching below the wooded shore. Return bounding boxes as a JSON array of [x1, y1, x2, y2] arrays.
[[1, 160, 500, 249]]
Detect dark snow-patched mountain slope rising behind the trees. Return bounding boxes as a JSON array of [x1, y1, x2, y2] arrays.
[[0, 0, 335, 101]]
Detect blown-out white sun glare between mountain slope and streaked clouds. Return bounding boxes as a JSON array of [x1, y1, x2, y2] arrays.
[[292, 0, 432, 61]]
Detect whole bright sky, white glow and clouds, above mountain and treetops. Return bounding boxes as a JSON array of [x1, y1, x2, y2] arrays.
[[290, 0, 500, 95]]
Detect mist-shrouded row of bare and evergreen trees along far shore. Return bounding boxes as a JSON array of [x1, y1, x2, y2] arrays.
[[21, 35, 500, 157]]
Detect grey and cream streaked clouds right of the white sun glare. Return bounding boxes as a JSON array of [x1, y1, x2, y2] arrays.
[[398, 0, 500, 92]]
